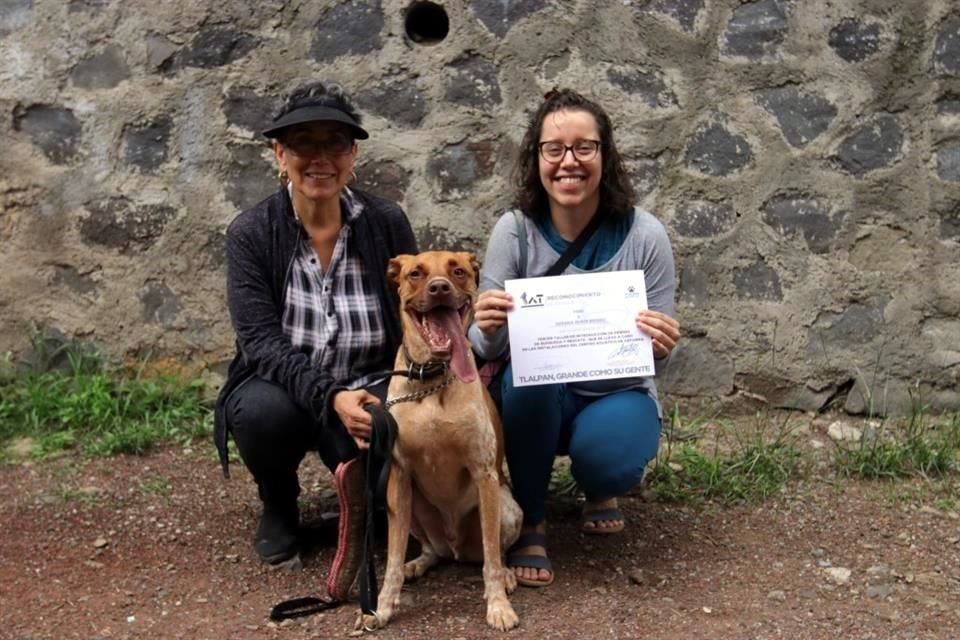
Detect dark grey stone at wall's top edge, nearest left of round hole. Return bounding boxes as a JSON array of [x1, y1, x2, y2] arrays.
[[310, 0, 383, 62]]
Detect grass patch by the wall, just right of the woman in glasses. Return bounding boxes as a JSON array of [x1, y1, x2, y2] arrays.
[[648, 409, 804, 505]]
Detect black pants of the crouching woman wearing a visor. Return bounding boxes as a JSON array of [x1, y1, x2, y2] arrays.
[[226, 377, 387, 507]]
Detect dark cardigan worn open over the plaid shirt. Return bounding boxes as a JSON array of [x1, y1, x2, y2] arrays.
[[213, 188, 417, 477]]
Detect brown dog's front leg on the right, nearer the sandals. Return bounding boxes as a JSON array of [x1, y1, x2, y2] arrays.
[[476, 470, 520, 631]]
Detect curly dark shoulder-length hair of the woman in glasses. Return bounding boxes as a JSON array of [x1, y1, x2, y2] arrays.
[[513, 89, 636, 218]]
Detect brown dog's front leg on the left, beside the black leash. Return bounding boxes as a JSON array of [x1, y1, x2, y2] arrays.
[[356, 460, 413, 630]]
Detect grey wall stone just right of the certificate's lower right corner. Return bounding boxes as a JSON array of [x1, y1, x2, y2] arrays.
[[657, 340, 734, 396]]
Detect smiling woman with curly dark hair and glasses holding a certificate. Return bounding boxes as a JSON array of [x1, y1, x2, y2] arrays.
[[469, 89, 680, 587]]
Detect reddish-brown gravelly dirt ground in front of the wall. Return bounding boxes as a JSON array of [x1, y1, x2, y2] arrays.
[[0, 410, 960, 640]]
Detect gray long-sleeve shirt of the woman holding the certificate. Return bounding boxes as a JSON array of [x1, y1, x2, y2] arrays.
[[468, 208, 676, 417]]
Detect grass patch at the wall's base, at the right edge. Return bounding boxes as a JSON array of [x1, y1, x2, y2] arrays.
[[834, 410, 960, 480]]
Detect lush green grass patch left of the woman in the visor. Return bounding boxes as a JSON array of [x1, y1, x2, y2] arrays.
[[0, 354, 212, 459]]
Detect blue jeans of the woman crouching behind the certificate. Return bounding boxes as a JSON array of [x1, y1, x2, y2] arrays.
[[501, 365, 660, 525]]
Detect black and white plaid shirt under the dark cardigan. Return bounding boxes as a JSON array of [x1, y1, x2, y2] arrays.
[[283, 188, 387, 389]]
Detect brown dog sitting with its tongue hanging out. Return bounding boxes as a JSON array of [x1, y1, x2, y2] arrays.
[[357, 251, 522, 631]]
